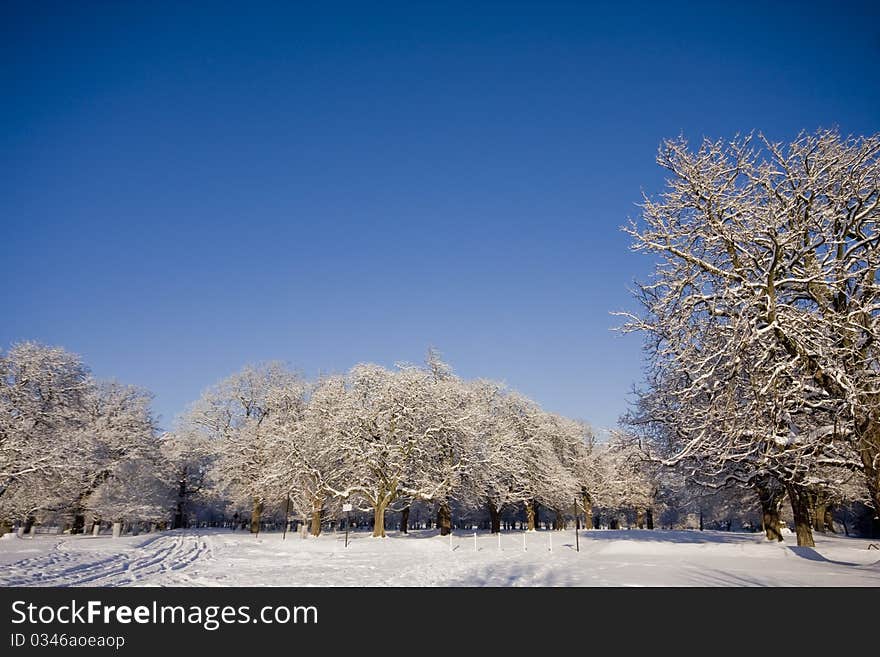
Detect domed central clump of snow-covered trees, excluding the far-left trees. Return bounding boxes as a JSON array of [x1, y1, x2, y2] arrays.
[[176, 352, 647, 536]]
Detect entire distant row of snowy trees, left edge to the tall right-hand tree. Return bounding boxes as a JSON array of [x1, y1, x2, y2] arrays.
[[0, 343, 652, 536]]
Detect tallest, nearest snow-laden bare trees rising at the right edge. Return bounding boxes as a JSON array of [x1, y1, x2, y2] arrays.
[[625, 131, 880, 545]]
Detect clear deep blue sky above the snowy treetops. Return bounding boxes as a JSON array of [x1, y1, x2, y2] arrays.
[[0, 2, 880, 436]]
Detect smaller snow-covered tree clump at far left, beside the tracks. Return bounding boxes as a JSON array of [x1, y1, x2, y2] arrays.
[[0, 342, 161, 533]]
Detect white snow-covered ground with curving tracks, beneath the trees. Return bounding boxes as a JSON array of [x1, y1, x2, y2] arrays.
[[0, 530, 880, 586]]
